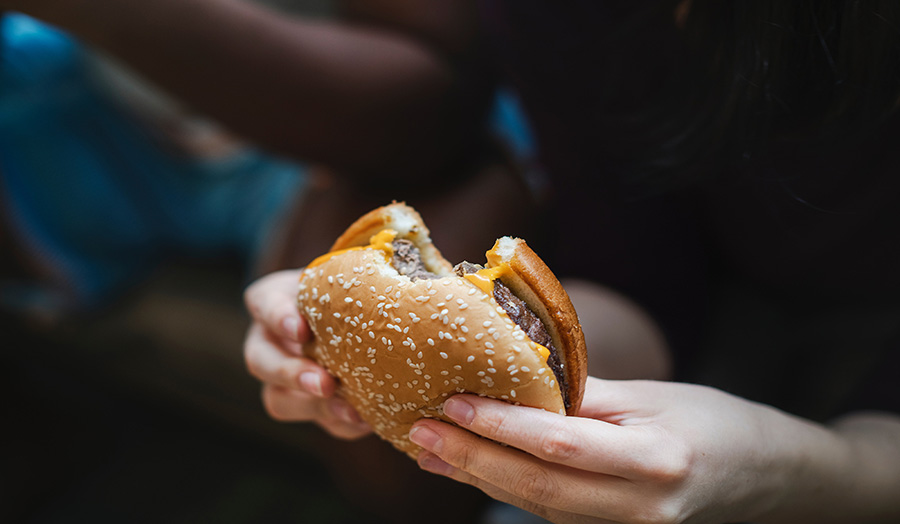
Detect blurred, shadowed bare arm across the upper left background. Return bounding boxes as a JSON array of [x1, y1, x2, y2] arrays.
[[7, 0, 486, 177]]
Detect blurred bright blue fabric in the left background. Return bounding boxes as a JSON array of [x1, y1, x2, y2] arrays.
[[0, 14, 306, 314]]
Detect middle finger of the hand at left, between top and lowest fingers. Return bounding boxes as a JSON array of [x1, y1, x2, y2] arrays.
[[244, 323, 337, 397]]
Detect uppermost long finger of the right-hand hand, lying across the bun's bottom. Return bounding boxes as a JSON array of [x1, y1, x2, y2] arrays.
[[444, 395, 658, 478]]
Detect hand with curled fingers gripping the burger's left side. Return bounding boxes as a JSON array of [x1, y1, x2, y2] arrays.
[[244, 270, 371, 439]]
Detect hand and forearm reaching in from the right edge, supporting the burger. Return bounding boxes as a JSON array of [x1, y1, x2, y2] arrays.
[[411, 378, 900, 523]]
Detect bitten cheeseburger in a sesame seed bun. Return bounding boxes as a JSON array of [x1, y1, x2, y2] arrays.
[[297, 203, 587, 457]]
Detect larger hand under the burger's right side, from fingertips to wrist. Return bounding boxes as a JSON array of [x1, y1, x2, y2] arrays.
[[410, 378, 813, 523]]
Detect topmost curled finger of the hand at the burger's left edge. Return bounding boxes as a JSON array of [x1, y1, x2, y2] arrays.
[[244, 270, 310, 343]]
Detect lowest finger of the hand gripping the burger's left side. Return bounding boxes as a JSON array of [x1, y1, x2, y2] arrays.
[[262, 385, 372, 439]]
